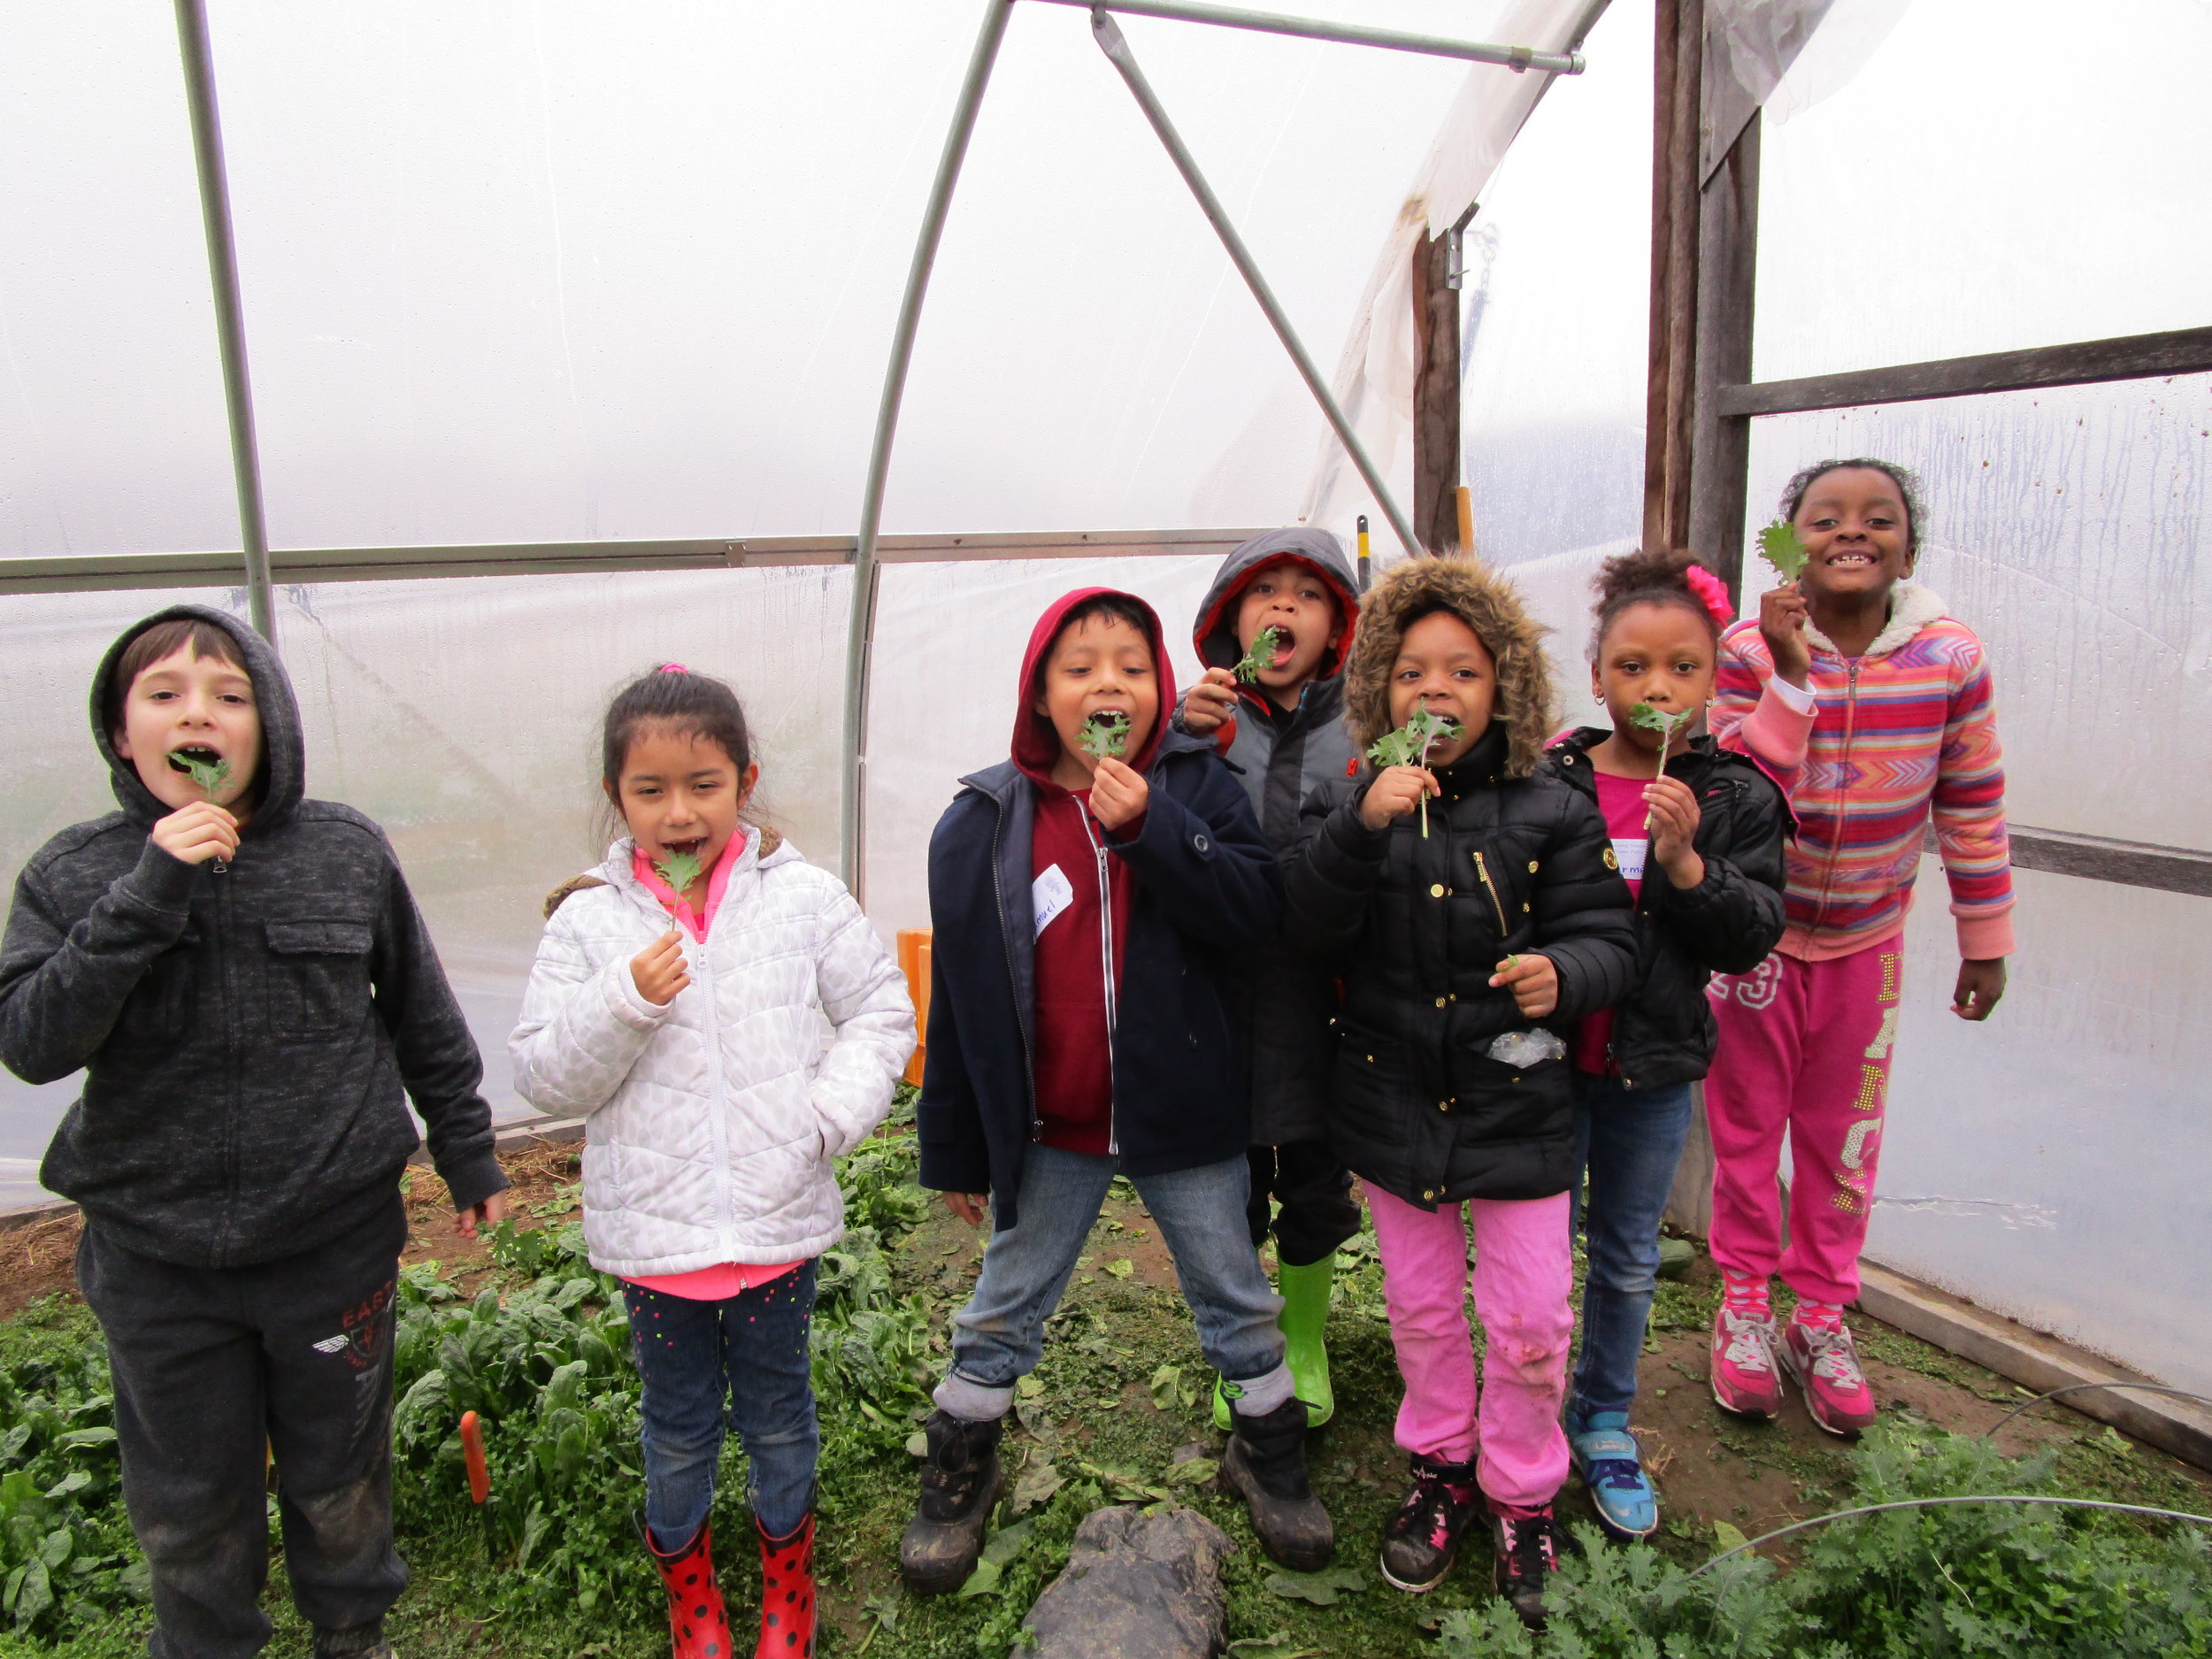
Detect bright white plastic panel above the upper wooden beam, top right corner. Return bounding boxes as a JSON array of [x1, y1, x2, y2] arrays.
[[1755, 0, 2212, 380]]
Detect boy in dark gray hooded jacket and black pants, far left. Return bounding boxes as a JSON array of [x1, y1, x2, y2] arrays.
[[0, 606, 507, 1659]]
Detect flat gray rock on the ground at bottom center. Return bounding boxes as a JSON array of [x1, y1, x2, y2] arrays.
[[1026, 1509, 1237, 1659]]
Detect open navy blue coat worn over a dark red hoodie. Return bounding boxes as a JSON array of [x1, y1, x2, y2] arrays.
[[918, 733, 1283, 1228]]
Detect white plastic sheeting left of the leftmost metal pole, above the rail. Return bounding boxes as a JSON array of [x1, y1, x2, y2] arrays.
[[0, 0, 239, 557]]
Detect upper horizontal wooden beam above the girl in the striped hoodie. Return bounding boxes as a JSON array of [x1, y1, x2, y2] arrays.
[[1719, 327, 2212, 416]]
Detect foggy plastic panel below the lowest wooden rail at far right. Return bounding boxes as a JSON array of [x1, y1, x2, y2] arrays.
[[1867, 858, 2212, 1392]]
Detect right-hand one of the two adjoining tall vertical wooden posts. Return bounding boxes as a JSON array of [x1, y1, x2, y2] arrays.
[[1686, 113, 1763, 602]]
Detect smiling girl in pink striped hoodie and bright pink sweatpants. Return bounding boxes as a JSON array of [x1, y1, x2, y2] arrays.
[[1706, 460, 2013, 1433]]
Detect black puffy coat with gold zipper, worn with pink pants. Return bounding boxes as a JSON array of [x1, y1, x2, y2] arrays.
[[1287, 726, 1635, 1210]]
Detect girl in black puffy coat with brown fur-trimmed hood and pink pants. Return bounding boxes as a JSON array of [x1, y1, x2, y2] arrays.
[[1287, 557, 1635, 1624]]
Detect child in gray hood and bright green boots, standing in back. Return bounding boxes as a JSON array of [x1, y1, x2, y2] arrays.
[[1175, 526, 1361, 1429]]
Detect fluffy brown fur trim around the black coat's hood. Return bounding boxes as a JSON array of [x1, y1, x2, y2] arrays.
[[1345, 556, 1557, 779]]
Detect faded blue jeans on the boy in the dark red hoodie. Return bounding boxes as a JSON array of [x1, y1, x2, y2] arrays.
[[938, 1144, 1292, 1420]]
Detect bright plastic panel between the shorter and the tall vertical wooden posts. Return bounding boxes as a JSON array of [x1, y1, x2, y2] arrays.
[[1460, 0, 1653, 580]]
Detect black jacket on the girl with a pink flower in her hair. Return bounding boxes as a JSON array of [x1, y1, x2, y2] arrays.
[[1544, 726, 1792, 1088]]
